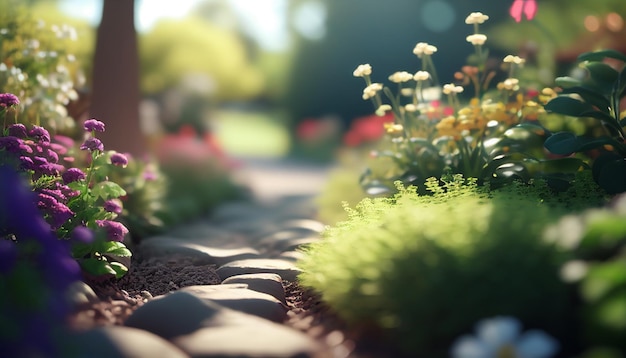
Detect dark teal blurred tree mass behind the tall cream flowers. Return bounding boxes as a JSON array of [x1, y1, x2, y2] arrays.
[[284, 0, 513, 129]]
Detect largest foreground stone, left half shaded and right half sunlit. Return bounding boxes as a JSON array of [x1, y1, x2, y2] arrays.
[[126, 288, 319, 357]]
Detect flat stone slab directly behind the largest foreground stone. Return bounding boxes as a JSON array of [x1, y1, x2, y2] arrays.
[[179, 283, 287, 322]]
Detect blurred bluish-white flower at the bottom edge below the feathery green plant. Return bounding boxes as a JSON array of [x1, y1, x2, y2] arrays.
[[450, 316, 559, 358]]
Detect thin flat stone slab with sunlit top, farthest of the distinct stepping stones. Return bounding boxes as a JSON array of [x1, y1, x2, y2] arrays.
[[217, 259, 302, 281]]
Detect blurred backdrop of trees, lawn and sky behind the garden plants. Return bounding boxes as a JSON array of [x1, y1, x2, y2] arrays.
[[0, 0, 626, 159]]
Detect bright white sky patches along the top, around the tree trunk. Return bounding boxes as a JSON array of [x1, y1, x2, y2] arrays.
[[61, 0, 288, 50]]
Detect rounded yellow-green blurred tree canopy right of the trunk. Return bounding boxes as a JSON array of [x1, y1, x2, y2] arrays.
[[139, 17, 264, 100]]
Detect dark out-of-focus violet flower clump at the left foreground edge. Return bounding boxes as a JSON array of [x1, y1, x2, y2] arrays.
[[0, 165, 80, 357]]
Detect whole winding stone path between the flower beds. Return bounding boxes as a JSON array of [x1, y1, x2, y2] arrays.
[[64, 161, 347, 358]]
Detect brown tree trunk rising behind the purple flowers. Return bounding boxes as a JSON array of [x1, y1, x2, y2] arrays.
[[90, 0, 147, 156]]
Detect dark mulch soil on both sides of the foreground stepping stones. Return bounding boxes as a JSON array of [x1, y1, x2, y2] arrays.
[[69, 250, 397, 358]]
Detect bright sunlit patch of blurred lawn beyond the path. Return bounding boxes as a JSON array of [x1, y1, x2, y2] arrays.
[[212, 109, 290, 157]]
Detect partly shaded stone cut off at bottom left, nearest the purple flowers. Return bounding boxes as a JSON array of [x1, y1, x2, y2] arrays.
[[67, 326, 189, 358]]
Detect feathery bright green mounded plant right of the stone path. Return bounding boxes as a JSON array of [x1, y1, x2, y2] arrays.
[[299, 176, 574, 357]]
